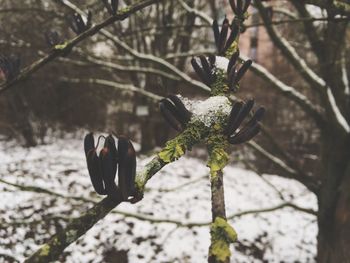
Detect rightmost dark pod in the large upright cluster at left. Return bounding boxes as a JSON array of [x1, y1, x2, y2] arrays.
[[118, 136, 136, 200]]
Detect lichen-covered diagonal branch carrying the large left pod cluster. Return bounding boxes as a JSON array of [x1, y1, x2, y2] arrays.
[[25, 123, 207, 263]]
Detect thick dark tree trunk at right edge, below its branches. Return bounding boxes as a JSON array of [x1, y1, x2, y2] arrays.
[[317, 133, 350, 263]]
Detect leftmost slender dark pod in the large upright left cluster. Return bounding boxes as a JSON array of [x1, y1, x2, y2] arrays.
[[84, 133, 107, 195]]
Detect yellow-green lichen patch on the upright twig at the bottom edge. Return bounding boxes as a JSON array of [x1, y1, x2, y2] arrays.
[[209, 217, 237, 262]]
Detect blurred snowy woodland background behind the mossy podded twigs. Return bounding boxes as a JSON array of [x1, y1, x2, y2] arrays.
[[0, 0, 350, 262]]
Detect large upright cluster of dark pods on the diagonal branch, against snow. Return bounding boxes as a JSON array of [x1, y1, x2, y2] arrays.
[[84, 133, 136, 202]]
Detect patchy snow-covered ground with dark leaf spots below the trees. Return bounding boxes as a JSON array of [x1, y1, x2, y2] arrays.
[[0, 135, 317, 263]]
